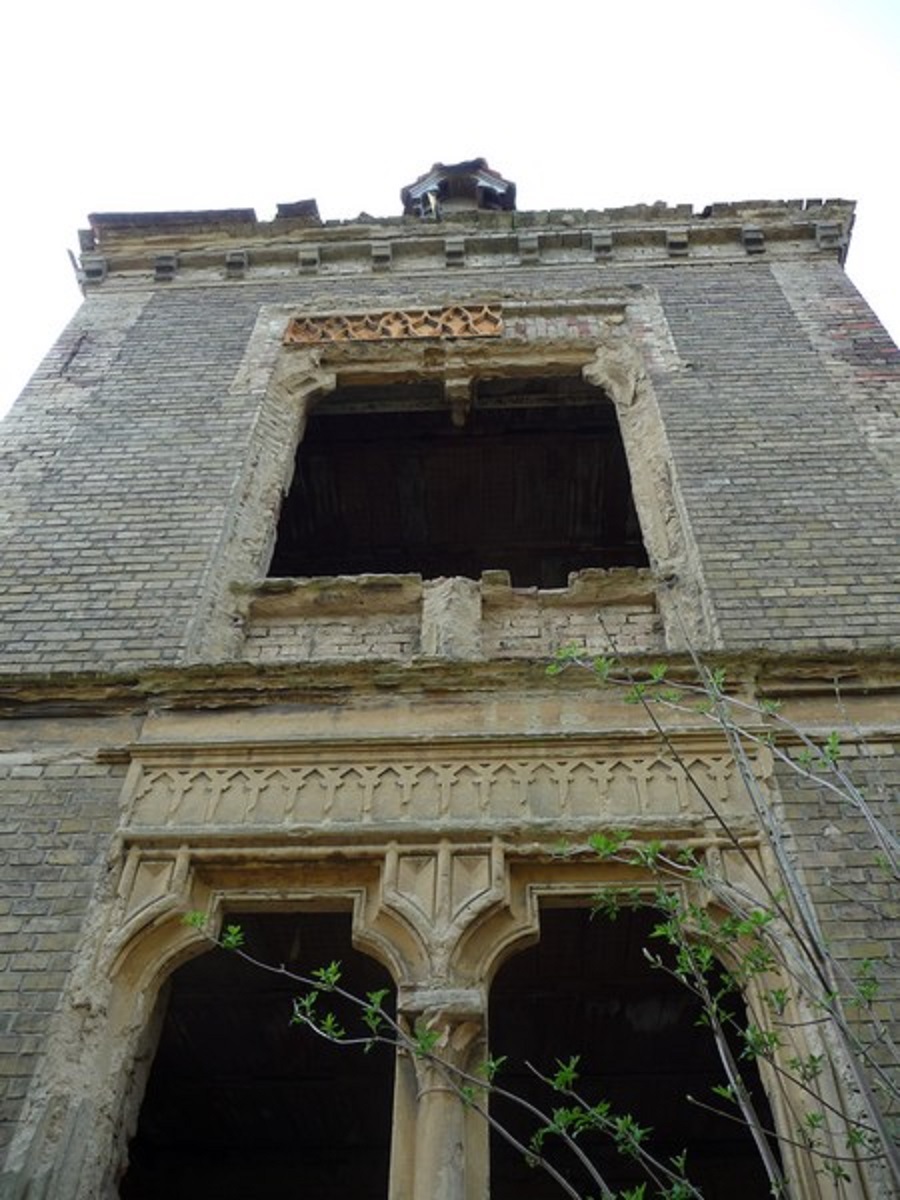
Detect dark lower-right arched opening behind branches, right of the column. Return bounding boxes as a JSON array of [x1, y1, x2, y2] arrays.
[[490, 908, 773, 1200]]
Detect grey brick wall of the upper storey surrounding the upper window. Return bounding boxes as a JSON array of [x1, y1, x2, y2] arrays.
[[0, 260, 900, 671]]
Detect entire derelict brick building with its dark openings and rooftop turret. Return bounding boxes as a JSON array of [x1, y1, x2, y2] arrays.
[[0, 160, 900, 1200]]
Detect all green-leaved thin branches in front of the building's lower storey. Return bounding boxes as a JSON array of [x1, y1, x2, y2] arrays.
[[180, 647, 900, 1200]]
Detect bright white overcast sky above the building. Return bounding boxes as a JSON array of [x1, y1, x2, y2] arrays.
[[0, 0, 900, 422]]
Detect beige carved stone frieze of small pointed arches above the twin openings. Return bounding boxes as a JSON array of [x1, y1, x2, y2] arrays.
[[122, 750, 770, 840]]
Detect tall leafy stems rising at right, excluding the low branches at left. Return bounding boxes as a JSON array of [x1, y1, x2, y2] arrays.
[[547, 646, 900, 1194]]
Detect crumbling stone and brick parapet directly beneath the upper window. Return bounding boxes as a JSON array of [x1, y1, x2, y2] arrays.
[[244, 568, 662, 662]]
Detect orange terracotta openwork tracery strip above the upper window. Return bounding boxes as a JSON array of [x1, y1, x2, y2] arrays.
[[284, 305, 503, 346]]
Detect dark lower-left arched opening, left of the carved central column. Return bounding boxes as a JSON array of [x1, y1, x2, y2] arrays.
[[120, 913, 394, 1200]]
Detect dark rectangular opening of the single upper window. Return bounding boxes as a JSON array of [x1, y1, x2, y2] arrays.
[[269, 376, 647, 588]]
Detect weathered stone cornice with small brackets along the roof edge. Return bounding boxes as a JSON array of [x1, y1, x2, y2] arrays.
[[79, 199, 853, 287]]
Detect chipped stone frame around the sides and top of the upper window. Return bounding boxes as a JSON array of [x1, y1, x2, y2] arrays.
[[207, 294, 721, 660]]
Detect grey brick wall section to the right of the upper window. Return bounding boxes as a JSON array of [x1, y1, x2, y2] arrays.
[[643, 264, 900, 649]]
